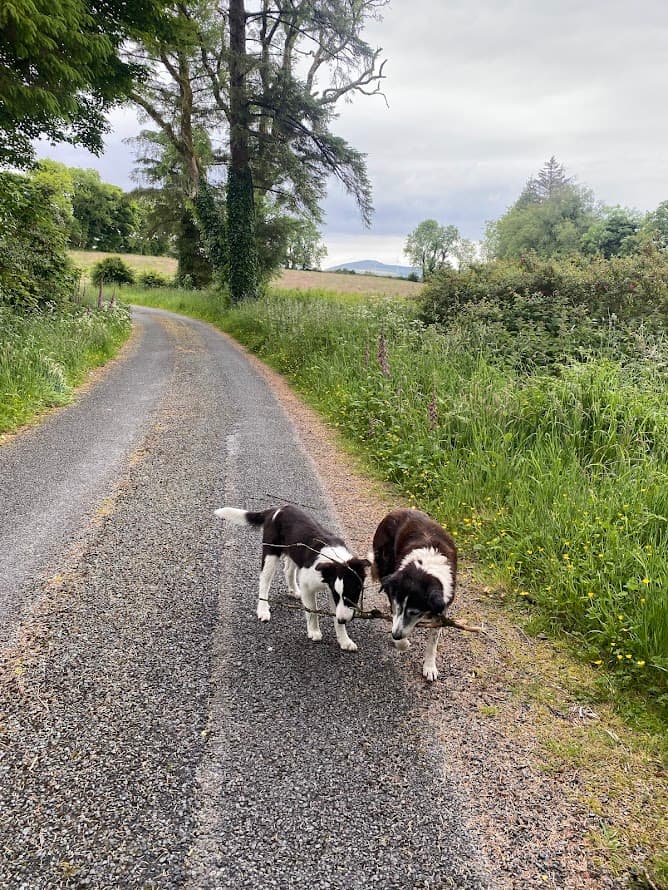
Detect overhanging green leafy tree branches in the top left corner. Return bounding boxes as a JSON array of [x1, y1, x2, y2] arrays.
[[0, 0, 167, 167]]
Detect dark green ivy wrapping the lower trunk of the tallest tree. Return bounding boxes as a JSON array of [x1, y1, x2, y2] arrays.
[[227, 167, 258, 303]]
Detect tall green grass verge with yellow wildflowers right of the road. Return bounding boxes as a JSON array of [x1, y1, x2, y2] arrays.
[[225, 293, 668, 704]]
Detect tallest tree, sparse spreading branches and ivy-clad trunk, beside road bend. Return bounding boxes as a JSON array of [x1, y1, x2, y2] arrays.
[[128, 0, 387, 299]]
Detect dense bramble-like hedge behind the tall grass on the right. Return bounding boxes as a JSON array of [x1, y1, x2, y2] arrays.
[[421, 253, 668, 367]]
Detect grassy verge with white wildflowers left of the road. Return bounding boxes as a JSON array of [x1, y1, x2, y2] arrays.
[[0, 306, 131, 433]]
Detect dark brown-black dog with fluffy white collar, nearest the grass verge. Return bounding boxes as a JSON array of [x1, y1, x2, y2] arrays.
[[372, 509, 457, 680]]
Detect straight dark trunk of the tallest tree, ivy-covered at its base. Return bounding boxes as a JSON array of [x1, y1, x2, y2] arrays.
[[227, 0, 258, 303]]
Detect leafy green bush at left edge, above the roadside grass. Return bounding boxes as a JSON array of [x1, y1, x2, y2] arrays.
[[0, 168, 77, 310]]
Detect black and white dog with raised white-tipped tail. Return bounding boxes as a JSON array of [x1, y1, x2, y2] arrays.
[[214, 505, 370, 652]]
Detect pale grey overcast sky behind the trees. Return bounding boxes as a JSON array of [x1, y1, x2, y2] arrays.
[[35, 0, 668, 267]]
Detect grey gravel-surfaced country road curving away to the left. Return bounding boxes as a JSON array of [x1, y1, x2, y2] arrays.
[[0, 309, 490, 890]]
